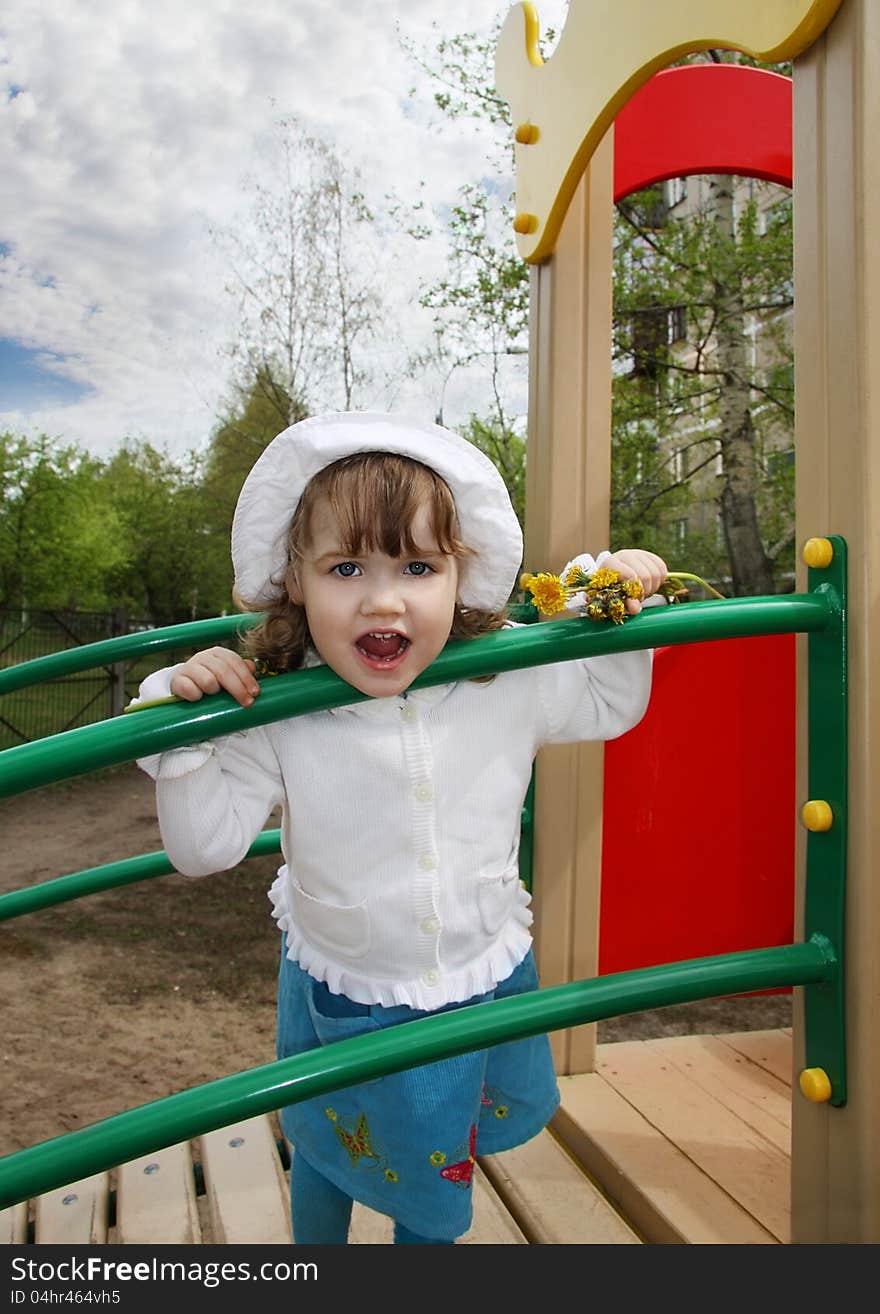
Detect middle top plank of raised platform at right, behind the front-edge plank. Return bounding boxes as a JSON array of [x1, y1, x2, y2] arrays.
[[645, 1035, 792, 1158]]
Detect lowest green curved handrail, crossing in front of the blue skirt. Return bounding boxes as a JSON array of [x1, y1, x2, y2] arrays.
[[0, 936, 837, 1209]]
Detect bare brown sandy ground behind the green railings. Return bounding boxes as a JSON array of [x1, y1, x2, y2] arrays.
[[0, 766, 791, 1154]]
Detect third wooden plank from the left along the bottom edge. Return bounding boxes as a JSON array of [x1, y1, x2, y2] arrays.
[[116, 1142, 202, 1246]]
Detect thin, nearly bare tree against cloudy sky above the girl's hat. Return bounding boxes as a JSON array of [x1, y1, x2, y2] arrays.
[[215, 118, 382, 420]]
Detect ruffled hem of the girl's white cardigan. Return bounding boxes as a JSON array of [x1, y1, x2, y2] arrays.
[[269, 866, 532, 1012]]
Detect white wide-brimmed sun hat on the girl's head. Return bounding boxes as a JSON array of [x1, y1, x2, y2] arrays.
[[232, 411, 523, 611]]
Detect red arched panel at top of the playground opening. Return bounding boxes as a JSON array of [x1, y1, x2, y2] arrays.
[[615, 64, 792, 201]]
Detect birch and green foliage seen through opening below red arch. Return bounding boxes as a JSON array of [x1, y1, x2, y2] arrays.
[[613, 177, 793, 594]]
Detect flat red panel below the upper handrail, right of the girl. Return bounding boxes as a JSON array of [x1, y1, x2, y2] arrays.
[[599, 635, 796, 974]]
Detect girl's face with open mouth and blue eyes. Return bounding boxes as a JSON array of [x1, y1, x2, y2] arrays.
[[289, 499, 458, 698]]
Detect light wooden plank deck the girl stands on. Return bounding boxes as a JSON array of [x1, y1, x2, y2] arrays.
[[0, 1030, 792, 1246]]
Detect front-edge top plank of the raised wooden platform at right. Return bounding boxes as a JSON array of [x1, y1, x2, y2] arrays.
[[596, 1041, 791, 1242]]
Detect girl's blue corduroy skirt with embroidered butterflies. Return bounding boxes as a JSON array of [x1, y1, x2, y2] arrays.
[[277, 937, 560, 1240]]
